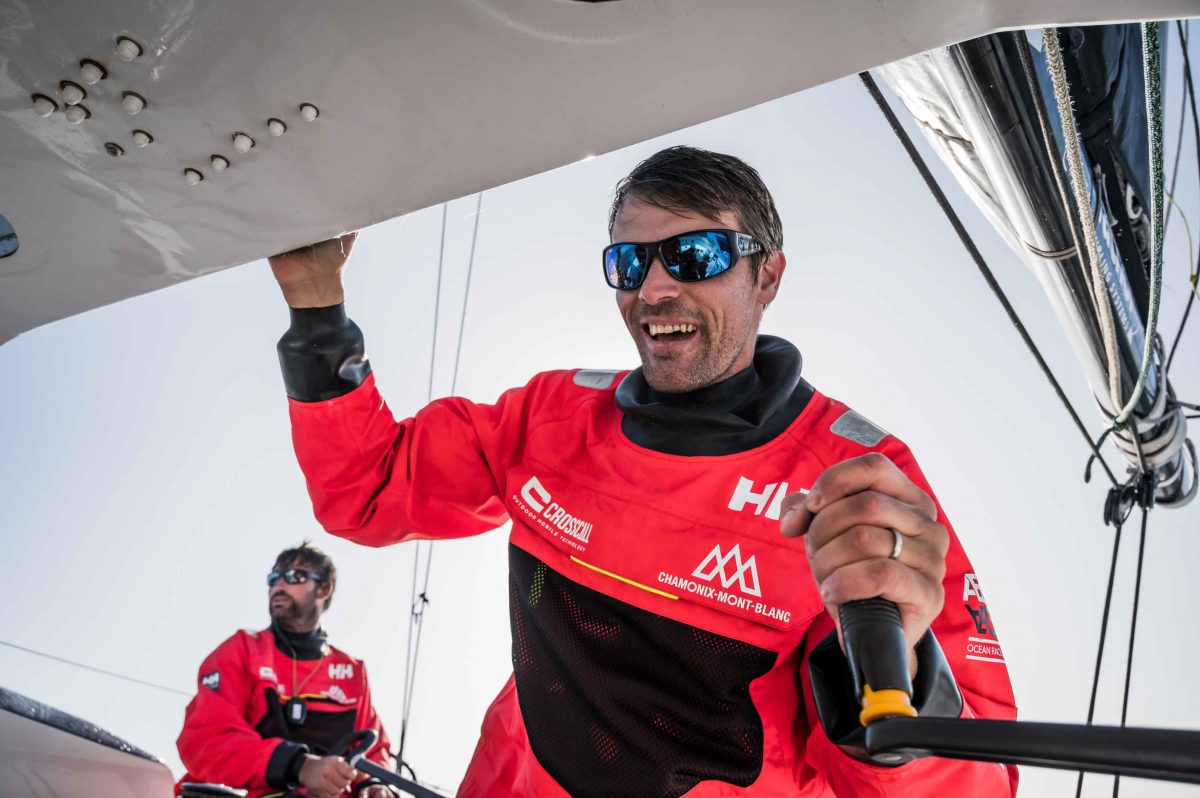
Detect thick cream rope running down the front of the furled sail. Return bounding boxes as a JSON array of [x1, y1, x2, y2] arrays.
[[1042, 28, 1122, 408]]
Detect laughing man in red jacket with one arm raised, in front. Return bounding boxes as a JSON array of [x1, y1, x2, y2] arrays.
[[271, 148, 1016, 798]]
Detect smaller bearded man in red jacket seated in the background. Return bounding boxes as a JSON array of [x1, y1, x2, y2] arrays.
[[178, 542, 392, 798]]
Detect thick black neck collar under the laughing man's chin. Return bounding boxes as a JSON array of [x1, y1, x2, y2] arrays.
[[616, 335, 812, 456]]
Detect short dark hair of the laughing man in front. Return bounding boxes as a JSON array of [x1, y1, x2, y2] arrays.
[[608, 146, 784, 282]]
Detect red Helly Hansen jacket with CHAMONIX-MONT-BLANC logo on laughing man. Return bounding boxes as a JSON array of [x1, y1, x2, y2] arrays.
[[289, 372, 1016, 798]]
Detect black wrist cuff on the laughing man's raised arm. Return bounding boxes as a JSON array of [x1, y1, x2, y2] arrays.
[[277, 305, 371, 402]]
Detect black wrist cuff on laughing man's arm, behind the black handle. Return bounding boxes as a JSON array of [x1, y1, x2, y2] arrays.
[[809, 630, 962, 767]]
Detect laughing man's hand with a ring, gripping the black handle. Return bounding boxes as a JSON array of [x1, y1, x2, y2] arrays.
[[780, 452, 950, 673]]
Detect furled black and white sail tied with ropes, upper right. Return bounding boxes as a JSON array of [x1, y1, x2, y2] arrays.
[[881, 25, 1196, 505]]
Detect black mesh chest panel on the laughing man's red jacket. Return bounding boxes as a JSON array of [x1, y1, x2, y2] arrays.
[[509, 545, 775, 798]]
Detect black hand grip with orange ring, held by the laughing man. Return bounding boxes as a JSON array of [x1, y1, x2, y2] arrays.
[[838, 596, 917, 726]]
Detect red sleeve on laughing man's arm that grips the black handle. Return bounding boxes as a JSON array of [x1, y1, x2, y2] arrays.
[[798, 437, 1018, 798]]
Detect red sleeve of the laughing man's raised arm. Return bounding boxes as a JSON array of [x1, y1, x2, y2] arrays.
[[288, 374, 527, 546]]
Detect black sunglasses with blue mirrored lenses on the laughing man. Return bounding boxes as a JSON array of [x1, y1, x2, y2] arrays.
[[604, 230, 762, 290]]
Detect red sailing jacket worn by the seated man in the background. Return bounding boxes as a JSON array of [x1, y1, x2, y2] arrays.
[[176, 629, 390, 798]]
